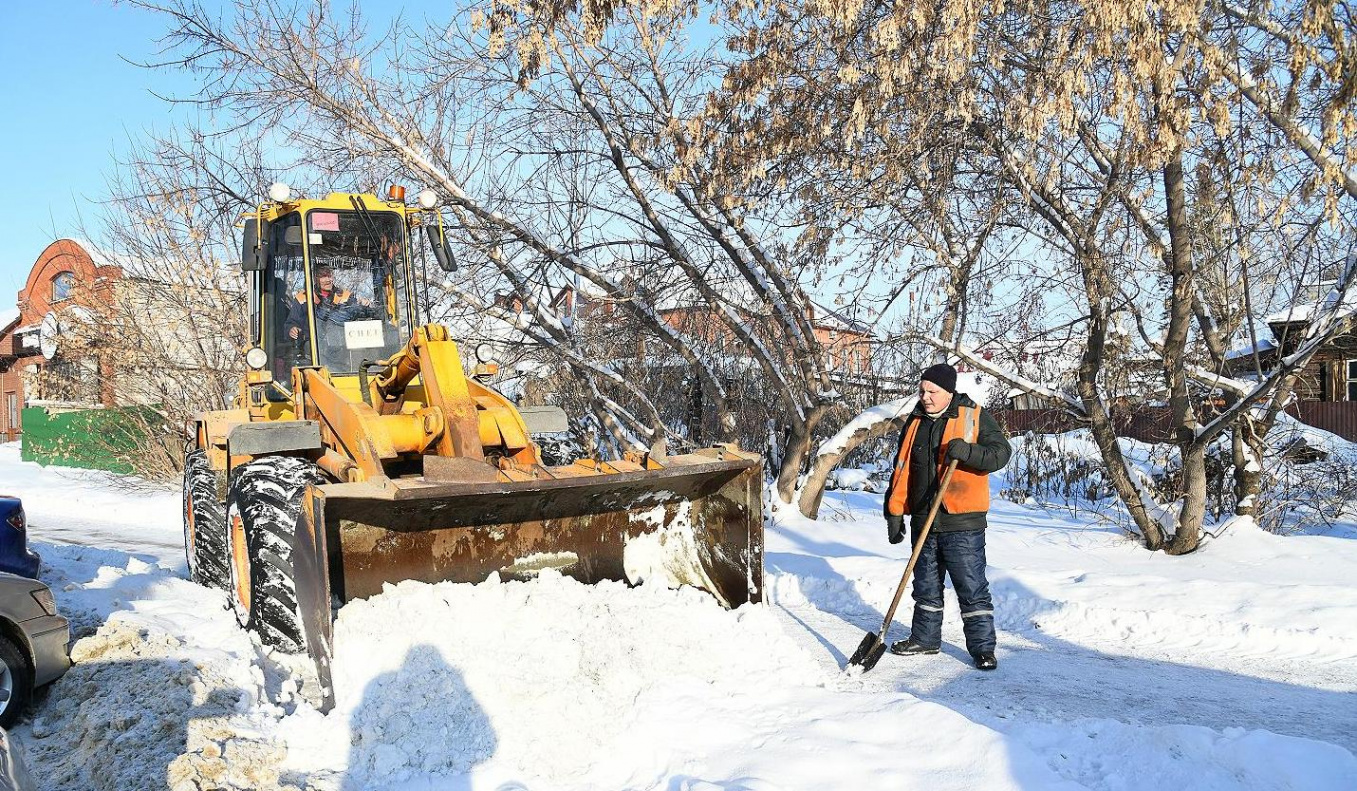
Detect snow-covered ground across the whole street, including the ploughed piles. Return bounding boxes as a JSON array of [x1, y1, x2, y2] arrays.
[[0, 445, 1357, 791]]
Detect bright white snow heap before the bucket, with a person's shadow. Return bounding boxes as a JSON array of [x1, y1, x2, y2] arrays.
[[280, 571, 821, 787]]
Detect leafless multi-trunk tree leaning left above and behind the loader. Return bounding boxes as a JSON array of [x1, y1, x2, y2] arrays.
[[132, 1, 922, 501]]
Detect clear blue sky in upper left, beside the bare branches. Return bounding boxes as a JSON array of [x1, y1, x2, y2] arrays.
[[0, 0, 191, 297]]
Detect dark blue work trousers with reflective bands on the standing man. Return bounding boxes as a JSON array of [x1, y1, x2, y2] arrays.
[[909, 529, 995, 654]]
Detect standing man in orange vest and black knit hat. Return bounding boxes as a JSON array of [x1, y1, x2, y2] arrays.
[[885, 364, 1012, 670]]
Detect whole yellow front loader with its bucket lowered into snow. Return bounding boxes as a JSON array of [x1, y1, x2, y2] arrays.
[[183, 185, 763, 704]]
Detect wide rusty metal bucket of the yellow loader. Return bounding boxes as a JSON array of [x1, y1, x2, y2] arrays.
[[293, 452, 763, 706]]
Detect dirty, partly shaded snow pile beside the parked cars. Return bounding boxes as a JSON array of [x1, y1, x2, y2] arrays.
[[22, 545, 301, 791]]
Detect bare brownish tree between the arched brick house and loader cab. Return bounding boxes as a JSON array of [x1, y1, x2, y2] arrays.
[[33, 132, 280, 479]]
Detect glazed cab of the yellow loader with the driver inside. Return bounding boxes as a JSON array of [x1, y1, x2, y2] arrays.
[[255, 195, 413, 389]]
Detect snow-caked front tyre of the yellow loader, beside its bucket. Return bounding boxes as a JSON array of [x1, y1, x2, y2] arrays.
[[227, 456, 328, 653]]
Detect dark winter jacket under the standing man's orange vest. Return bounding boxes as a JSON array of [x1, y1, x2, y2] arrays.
[[885, 393, 1012, 533]]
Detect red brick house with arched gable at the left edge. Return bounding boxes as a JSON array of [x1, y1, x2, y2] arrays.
[[0, 239, 122, 441]]
